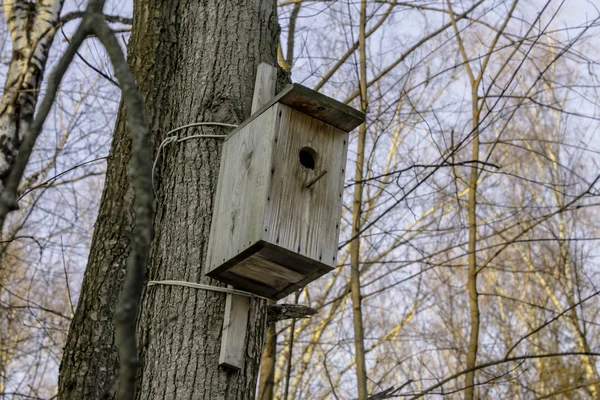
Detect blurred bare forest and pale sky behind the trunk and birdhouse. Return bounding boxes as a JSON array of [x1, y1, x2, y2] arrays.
[[0, 0, 600, 400]]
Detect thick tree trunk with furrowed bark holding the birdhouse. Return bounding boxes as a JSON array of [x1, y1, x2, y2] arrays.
[[59, 0, 278, 399]]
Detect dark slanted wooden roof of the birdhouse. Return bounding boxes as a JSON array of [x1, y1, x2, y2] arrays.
[[227, 83, 365, 139]]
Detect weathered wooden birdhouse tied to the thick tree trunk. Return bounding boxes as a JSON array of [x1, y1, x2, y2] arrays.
[[207, 84, 365, 299]]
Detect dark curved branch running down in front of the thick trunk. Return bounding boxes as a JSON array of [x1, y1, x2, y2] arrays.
[[89, 9, 154, 400]]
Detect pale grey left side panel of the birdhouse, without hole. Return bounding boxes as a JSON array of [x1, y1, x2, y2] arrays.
[[207, 107, 278, 271]]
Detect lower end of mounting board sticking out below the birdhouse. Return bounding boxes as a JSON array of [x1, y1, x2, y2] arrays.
[[219, 294, 250, 369]]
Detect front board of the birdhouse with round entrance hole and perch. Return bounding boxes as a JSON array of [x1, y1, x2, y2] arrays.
[[263, 104, 348, 266]]
